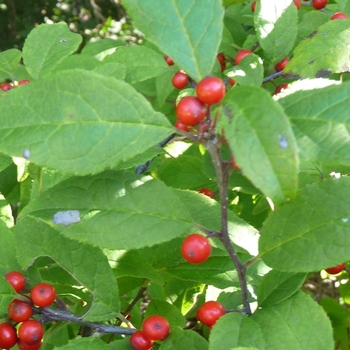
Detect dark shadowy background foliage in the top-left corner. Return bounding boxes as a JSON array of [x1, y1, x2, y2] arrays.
[[0, 0, 136, 51]]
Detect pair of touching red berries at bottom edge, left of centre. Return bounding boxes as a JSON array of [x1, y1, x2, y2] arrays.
[[130, 315, 170, 350]]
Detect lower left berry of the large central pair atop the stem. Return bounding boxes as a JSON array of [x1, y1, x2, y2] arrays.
[[176, 96, 208, 126]]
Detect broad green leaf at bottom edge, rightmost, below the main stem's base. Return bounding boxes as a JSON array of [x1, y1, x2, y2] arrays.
[[251, 292, 334, 350]]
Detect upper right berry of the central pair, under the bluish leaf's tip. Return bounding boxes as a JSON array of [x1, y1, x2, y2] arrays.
[[196, 76, 226, 105]]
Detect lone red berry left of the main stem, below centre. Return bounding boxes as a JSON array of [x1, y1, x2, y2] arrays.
[[181, 233, 211, 264]]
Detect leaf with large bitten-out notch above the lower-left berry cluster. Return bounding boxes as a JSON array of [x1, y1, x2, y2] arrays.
[[15, 216, 119, 321]]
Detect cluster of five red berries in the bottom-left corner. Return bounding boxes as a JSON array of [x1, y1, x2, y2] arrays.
[[0, 271, 56, 350]]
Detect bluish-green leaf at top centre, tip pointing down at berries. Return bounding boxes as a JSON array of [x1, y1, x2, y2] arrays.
[[123, 0, 224, 81]]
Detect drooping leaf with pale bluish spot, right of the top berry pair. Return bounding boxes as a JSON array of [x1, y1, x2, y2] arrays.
[[221, 86, 299, 205]]
